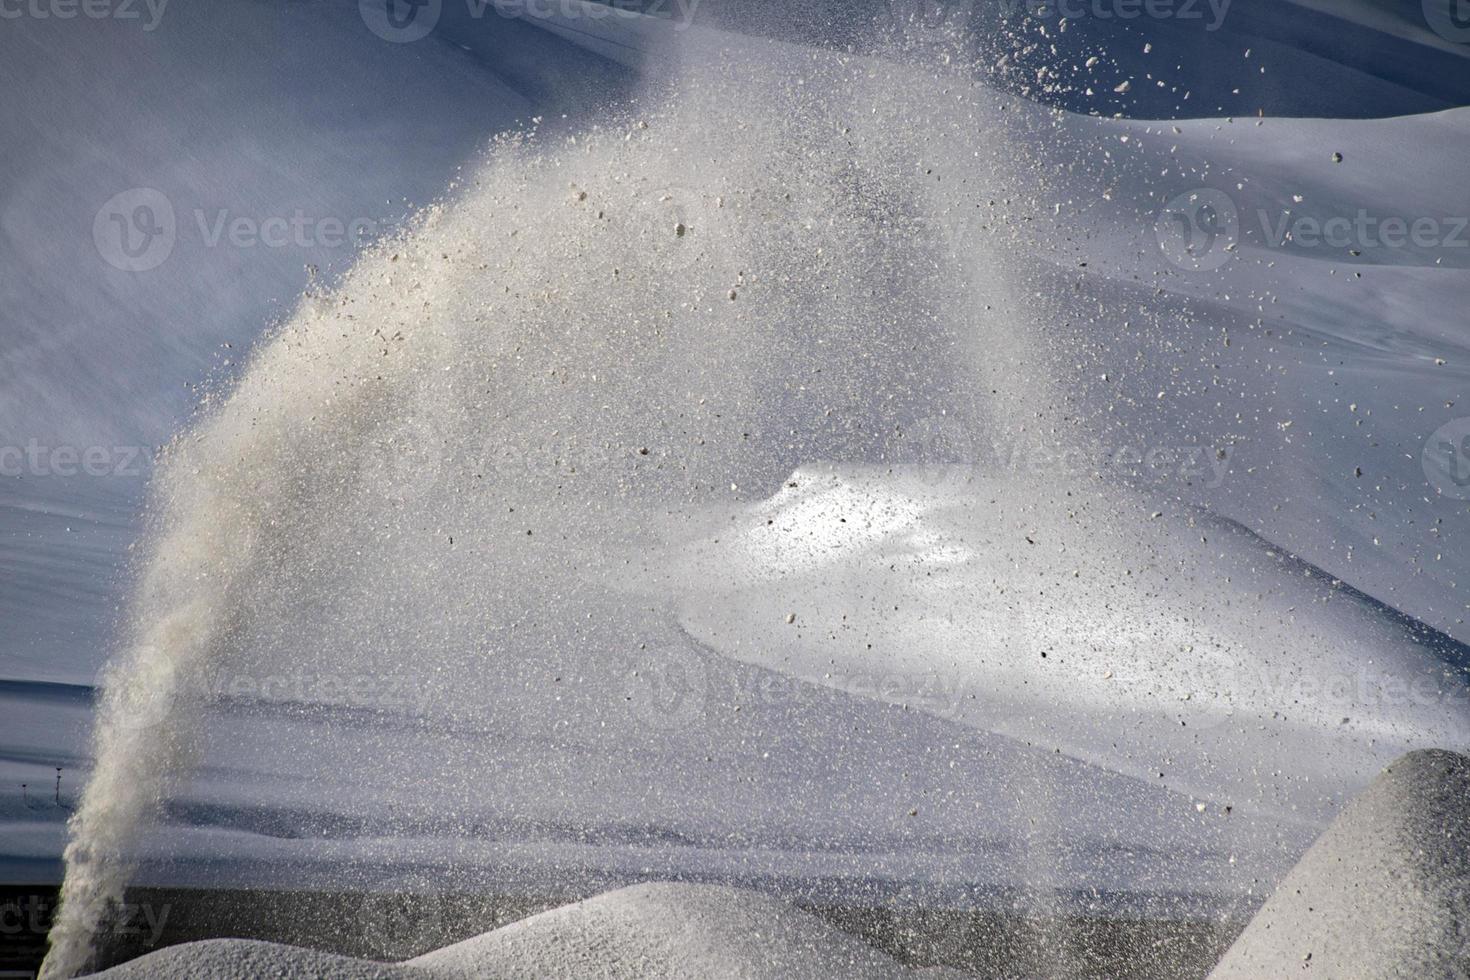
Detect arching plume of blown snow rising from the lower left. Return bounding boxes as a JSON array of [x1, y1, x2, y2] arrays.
[[43, 34, 1045, 979]]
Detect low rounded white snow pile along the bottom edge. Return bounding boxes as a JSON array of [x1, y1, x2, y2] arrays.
[[97, 883, 958, 980]]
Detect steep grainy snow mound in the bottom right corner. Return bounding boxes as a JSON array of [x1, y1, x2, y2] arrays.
[[1210, 749, 1470, 980]]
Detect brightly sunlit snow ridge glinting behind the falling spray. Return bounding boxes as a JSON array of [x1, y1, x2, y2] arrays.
[[637, 469, 1470, 820]]
